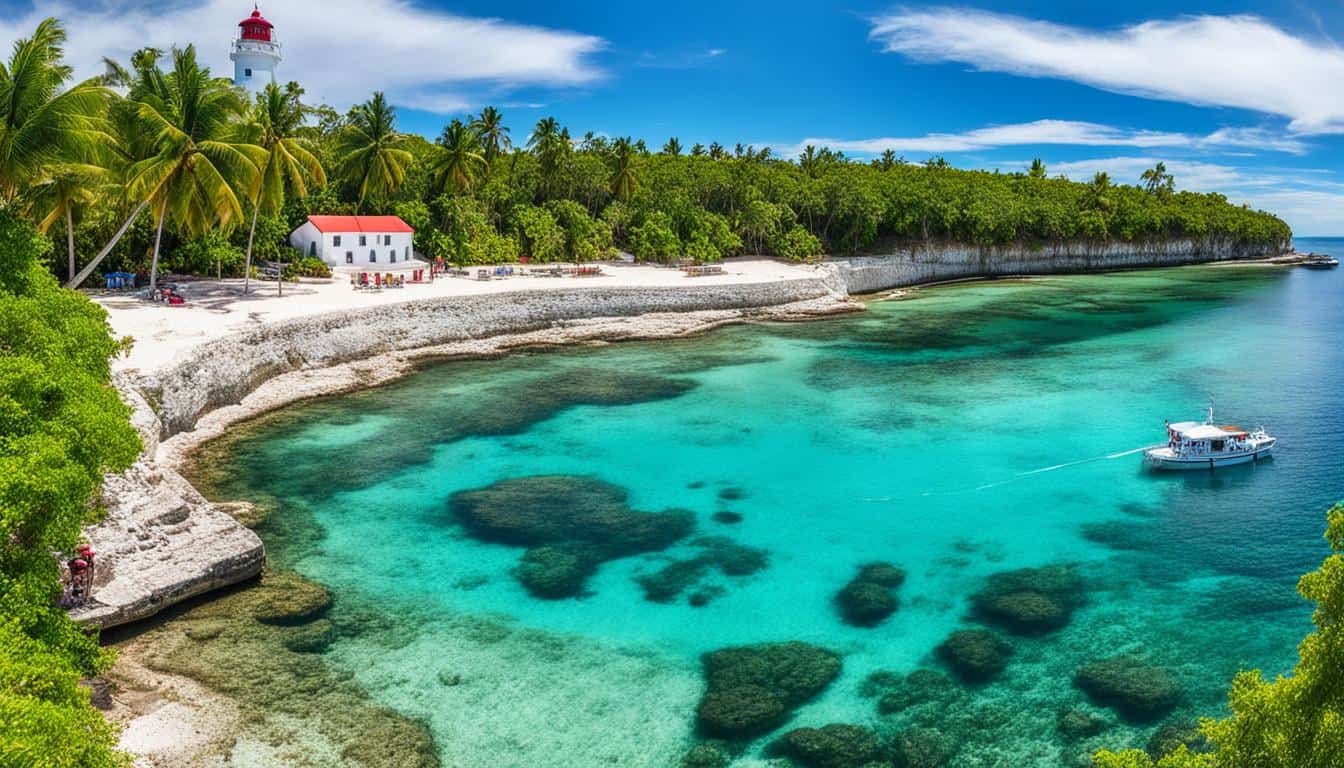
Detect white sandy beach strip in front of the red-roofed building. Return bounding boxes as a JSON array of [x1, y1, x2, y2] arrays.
[[93, 258, 816, 371]]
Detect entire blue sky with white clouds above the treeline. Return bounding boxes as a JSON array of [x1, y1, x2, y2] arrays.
[[0, 0, 1344, 235]]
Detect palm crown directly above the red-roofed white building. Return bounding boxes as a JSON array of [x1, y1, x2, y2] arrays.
[[336, 91, 414, 207]]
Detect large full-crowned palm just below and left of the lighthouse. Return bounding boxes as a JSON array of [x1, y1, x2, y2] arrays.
[[128, 46, 266, 292]]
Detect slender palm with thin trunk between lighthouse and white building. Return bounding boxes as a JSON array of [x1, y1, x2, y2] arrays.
[[243, 83, 327, 293]]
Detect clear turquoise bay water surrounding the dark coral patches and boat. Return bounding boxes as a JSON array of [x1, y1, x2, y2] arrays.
[[201, 260, 1344, 767]]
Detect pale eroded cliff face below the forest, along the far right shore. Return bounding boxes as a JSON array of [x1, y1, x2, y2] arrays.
[[831, 239, 1292, 293]]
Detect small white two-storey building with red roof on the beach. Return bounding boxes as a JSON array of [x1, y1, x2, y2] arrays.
[[289, 217, 426, 272]]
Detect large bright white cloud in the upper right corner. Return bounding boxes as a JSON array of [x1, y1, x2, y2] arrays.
[[871, 8, 1344, 133]]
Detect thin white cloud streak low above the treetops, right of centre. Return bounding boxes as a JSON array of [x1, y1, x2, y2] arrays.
[[775, 120, 1306, 157]]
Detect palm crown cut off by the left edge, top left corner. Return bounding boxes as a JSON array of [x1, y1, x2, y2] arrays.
[[0, 19, 110, 203]]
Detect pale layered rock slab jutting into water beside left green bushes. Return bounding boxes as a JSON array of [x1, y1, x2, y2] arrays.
[[71, 386, 265, 628]]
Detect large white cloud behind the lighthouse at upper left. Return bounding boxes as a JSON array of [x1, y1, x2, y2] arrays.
[[0, 0, 605, 113]]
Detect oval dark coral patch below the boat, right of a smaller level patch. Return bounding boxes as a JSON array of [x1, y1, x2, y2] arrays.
[[973, 565, 1085, 635]]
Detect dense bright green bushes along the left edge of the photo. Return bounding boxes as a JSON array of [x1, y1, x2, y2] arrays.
[[0, 210, 140, 768]]
